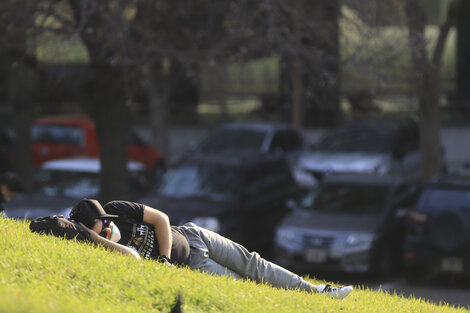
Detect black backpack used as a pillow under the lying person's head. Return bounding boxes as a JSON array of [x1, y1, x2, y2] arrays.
[[29, 215, 91, 242]]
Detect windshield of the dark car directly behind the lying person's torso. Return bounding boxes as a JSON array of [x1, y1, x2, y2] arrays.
[[157, 164, 241, 201]]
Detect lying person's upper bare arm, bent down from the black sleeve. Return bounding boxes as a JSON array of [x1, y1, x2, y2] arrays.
[[143, 206, 173, 258]]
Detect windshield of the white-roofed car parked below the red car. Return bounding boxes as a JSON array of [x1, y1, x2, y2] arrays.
[[32, 169, 99, 199]]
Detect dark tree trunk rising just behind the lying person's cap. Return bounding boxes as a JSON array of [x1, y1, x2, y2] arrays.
[[68, 0, 131, 202]]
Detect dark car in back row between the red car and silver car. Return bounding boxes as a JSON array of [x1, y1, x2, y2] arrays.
[[182, 122, 309, 169]]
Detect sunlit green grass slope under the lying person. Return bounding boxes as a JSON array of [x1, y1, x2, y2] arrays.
[[0, 218, 467, 313]]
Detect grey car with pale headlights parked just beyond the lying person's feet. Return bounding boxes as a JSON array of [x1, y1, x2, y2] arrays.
[[275, 174, 420, 277]]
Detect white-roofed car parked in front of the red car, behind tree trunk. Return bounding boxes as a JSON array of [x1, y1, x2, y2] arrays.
[[5, 158, 149, 219]]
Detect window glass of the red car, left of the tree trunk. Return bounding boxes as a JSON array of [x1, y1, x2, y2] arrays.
[[31, 125, 85, 145]]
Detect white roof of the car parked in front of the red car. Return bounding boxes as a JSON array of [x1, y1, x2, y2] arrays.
[[41, 158, 145, 173]]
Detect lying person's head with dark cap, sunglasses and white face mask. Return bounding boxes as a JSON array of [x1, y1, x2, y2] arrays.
[[70, 199, 121, 242]]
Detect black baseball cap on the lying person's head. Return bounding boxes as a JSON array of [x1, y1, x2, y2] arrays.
[[70, 199, 119, 228]]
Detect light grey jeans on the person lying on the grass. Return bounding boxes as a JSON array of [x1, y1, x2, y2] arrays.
[[179, 223, 315, 292]]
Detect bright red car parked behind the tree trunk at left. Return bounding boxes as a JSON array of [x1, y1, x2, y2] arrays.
[[31, 116, 164, 173]]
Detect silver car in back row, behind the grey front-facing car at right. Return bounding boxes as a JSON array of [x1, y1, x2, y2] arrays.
[[294, 120, 419, 188]]
